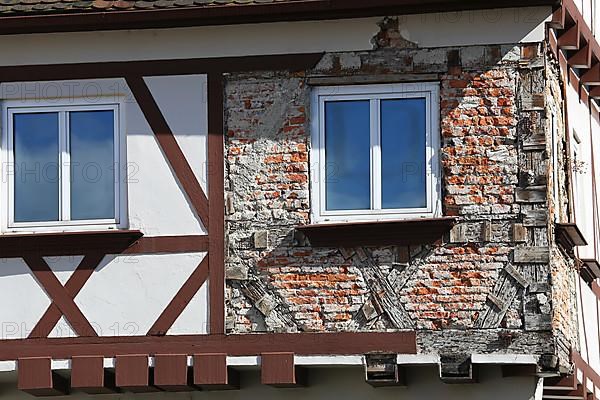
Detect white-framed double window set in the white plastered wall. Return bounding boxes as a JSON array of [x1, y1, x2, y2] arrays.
[[2, 98, 126, 232]]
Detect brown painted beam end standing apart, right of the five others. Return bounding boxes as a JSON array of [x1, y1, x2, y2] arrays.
[[261, 353, 306, 388]]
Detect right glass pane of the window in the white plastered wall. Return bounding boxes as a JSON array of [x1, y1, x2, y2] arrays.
[[69, 111, 115, 220]]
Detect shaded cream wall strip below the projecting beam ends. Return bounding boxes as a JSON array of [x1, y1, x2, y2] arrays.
[[0, 366, 541, 400]]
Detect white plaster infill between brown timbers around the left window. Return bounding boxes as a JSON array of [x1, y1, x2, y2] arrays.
[[0, 75, 208, 339]]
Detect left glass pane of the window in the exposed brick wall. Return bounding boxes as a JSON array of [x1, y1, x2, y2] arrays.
[[325, 101, 371, 210]]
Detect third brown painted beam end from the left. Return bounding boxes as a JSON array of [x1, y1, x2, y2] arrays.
[[115, 354, 156, 393]]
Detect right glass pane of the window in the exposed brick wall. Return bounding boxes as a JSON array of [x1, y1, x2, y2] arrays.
[[381, 99, 427, 209]]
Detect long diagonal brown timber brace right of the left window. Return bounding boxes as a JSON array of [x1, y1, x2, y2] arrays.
[[125, 75, 209, 228]]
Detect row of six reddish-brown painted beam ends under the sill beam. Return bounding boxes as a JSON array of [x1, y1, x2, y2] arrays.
[[17, 353, 305, 396]]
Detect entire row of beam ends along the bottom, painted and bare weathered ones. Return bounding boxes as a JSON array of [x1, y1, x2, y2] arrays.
[[17, 353, 552, 396]]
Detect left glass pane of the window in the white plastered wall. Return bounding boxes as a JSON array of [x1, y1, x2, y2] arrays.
[[13, 113, 59, 222]]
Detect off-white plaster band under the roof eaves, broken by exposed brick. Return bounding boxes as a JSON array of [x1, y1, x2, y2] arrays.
[[0, 7, 552, 65]]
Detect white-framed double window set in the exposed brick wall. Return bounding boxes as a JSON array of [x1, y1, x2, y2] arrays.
[[311, 83, 441, 222]]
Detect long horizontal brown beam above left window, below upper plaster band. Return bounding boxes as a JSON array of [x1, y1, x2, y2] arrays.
[[0, 53, 323, 83]]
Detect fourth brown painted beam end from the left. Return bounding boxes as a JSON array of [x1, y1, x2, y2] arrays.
[[154, 354, 192, 392]]
